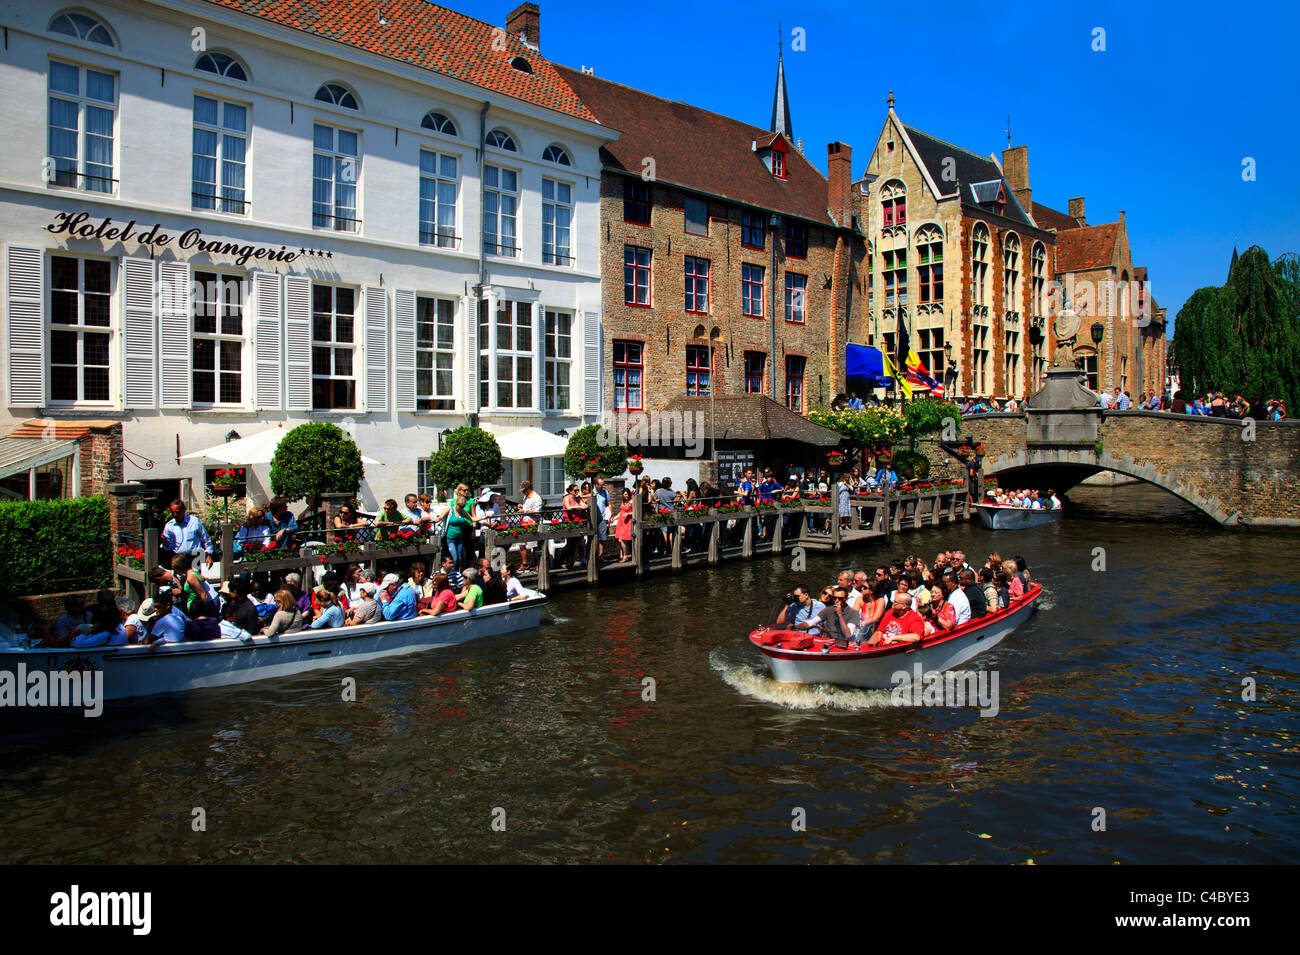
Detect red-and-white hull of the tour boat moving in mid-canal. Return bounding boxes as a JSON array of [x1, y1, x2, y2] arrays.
[[749, 583, 1043, 689]]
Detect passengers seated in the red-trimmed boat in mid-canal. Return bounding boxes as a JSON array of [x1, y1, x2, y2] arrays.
[[774, 551, 1032, 651]]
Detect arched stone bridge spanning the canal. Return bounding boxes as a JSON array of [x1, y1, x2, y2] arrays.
[[946, 403, 1300, 528]]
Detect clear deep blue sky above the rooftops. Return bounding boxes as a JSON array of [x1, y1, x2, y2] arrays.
[[460, 0, 1300, 335]]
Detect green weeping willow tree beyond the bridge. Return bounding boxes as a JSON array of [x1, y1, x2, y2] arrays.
[[1174, 246, 1300, 411]]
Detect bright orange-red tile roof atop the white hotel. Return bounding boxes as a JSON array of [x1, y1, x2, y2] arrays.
[[207, 0, 595, 121]]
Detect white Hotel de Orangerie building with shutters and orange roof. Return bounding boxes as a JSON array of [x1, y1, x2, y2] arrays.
[[0, 0, 616, 505]]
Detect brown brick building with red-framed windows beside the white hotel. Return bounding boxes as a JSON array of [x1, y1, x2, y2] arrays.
[[560, 54, 865, 412]]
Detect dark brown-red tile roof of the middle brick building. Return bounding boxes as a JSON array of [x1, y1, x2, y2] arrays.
[[558, 66, 835, 226]]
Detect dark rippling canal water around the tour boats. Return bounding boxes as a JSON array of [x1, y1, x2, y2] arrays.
[[0, 486, 1300, 864]]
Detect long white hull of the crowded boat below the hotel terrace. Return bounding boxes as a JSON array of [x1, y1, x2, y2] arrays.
[[0, 590, 547, 700]]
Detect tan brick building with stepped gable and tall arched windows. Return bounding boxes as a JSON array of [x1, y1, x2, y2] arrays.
[[854, 100, 1056, 396]]
